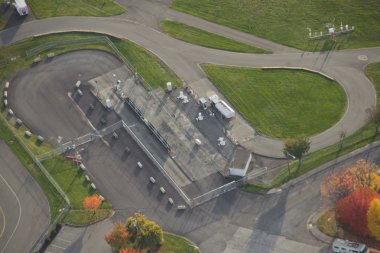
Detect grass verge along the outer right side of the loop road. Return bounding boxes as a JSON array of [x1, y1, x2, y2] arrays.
[[243, 63, 380, 192]]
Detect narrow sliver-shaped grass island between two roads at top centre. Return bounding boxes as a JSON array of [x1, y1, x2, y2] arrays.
[[160, 20, 269, 53]]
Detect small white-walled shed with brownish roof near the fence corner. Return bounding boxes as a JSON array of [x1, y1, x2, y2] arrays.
[[229, 148, 252, 177]]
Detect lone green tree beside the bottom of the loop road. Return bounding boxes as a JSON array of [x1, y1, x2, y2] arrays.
[[283, 136, 310, 168]]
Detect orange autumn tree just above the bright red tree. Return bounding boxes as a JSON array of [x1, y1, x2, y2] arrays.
[[321, 160, 380, 200]]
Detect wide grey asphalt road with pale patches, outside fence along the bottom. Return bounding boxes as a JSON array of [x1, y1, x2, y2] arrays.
[[46, 142, 380, 253]]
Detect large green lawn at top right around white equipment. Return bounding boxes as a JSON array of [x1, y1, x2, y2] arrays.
[[171, 0, 380, 51]]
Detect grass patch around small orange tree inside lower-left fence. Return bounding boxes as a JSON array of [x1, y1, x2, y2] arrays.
[[42, 157, 112, 224]]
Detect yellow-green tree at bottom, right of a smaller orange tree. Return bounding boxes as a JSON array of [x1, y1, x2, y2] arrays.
[[127, 213, 164, 251]]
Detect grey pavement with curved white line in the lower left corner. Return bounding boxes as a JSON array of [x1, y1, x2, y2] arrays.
[[0, 140, 50, 253]]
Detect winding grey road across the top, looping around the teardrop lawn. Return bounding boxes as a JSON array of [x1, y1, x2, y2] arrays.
[[0, 14, 380, 157]]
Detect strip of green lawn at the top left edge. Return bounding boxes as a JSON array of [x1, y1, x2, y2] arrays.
[[28, 0, 126, 19]]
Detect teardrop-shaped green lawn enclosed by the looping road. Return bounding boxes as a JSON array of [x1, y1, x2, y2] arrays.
[[203, 65, 346, 138]]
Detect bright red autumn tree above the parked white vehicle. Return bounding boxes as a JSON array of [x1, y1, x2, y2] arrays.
[[336, 188, 378, 236]]
